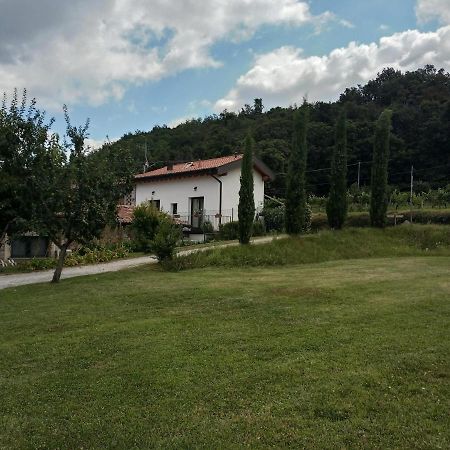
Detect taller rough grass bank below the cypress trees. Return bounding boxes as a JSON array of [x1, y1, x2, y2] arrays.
[[164, 225, 450, 271]]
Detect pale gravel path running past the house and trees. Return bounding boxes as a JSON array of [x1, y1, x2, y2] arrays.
[[0, 236, 282, 289]]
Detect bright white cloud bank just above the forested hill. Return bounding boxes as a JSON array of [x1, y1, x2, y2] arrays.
[[214, 26, 450, 111]]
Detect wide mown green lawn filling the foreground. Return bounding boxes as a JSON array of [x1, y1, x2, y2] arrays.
[[0, 256, 450, 449]]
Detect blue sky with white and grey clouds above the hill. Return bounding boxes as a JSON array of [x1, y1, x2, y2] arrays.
[[0, 0, 450, 147]]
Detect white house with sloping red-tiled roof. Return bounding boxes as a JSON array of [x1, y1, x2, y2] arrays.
[[135, 155, 273, 233]]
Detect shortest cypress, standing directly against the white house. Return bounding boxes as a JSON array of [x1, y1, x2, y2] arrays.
[[238, 134, 255, 244]]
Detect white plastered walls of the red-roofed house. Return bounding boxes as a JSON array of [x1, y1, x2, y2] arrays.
[[136, 167, 264, 227]]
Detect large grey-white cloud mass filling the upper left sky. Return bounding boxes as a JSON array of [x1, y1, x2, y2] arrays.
[[0, 0, 337, 108]]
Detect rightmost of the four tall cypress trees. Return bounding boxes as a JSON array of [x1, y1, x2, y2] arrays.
[[370, 109, 392, 228]]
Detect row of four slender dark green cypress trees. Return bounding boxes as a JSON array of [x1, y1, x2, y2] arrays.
[[239, 102, 392, 244]]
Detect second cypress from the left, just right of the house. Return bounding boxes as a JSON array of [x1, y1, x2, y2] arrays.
[[284, 102, 308, 234]]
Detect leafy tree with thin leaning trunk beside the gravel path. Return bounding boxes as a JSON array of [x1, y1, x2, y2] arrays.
[[30, 107, 132, 282]]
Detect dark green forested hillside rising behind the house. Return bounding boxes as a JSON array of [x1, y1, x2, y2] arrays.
[[105, 66, 450, 197]]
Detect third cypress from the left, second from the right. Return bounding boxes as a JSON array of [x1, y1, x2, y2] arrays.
[[327, 110, 348, 230]]
